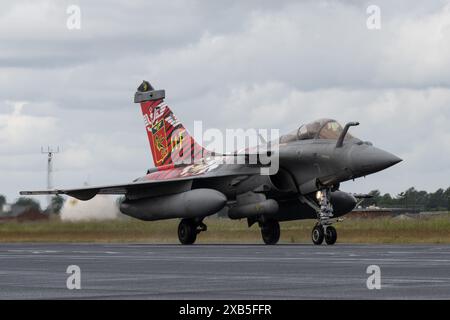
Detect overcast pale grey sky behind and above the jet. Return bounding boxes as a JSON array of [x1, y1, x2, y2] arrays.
[[0, 0, 450, 202]]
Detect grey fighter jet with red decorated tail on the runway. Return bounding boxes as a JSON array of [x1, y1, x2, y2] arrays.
[[20, 81, 402, 245]]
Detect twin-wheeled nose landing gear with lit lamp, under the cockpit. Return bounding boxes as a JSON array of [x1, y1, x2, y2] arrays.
[[311, 189, 337, 245]]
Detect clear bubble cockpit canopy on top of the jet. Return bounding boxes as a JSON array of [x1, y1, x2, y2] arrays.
[[280, 119, 353, 143]]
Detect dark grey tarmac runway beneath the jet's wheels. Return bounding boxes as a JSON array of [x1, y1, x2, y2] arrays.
[[0, 244, 450, 299]]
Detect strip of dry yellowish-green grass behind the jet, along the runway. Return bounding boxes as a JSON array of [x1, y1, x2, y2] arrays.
[[0, 214, 450, 244]]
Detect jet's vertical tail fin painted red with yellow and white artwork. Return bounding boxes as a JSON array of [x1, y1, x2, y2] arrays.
[[134, 81, 206, 167]]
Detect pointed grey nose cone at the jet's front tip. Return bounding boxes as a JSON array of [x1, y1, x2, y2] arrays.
[[351, 146, 402, 176]]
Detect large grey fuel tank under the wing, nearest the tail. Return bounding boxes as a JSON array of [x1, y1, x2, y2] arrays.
[[120, 189, 227, 221]]
